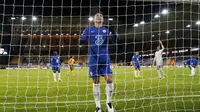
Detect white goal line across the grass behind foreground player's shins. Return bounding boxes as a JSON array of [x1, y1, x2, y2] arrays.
[[0, 95, 200, 105]]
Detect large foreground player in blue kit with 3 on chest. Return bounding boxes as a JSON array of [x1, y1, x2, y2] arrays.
[[80, 13, 119, 112]]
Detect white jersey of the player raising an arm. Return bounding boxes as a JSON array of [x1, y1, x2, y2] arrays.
[[154, 47, 164, 66]]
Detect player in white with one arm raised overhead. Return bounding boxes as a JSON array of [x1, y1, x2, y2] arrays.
[[153, 41, 166, 79]]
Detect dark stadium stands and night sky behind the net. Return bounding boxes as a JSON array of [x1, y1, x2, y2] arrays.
[[0, 0, 200, 64]]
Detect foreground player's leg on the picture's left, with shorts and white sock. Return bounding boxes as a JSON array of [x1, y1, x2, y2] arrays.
[[89, 66, 101, 112]]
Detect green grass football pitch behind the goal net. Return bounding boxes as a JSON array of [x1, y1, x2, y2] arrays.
[[0, 68, 200, 112]]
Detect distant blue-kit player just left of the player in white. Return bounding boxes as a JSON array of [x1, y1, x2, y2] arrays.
[[132, 52, 140, 77]]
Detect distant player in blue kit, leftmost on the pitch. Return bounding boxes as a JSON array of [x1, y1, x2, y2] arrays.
[[51, 51, 62, 82]]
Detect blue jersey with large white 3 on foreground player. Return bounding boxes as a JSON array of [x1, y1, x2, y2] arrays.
[[80, 26, 119, 66]]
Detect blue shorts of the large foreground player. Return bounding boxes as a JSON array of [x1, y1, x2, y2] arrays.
[[89, 64, 112, 78]]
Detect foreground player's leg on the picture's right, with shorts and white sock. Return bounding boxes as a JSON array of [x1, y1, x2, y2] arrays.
[[100, 64, 114, 112]]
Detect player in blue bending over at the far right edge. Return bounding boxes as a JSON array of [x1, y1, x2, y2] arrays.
[[185, 58, 198, 76]]
